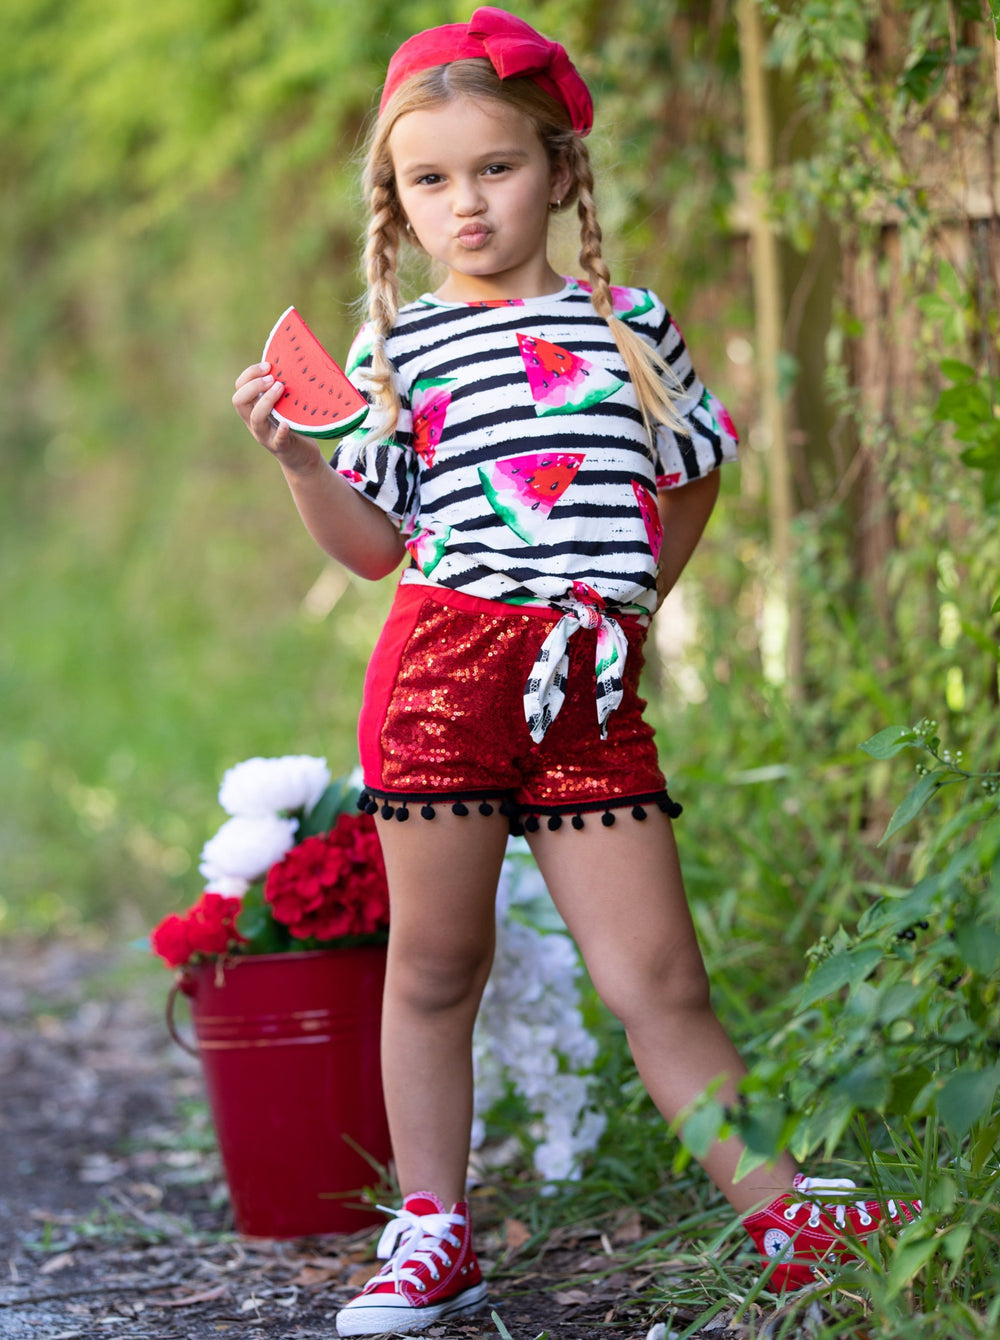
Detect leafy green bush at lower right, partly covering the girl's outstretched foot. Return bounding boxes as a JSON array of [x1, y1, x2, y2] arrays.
[[662, 721, 1000, 1336]]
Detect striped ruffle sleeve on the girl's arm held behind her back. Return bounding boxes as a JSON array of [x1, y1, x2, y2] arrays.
[[655, 311, 739, 489]]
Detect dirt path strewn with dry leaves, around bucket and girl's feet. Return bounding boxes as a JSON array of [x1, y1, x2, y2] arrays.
[[0, 942, 761, 1340]]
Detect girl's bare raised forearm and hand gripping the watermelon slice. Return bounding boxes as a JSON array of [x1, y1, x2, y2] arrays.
[[233, 363, 405, 582]]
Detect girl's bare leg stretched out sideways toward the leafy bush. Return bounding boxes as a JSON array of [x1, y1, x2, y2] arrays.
[[528, 811, 798, 1214]]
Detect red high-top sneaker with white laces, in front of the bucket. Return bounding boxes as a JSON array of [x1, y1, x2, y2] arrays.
[[336, 1191, 487, 1336]]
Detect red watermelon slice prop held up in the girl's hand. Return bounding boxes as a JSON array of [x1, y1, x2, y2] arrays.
[[261, 307, 369, 438]]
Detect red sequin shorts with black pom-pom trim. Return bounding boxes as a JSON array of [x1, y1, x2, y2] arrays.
[[358, 583, 681, 832]]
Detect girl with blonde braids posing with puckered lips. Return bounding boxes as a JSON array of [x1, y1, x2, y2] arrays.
[[233, 8, 914, 1336]]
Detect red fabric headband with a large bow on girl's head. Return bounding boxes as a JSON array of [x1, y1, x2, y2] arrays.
[[378, 5, 594, 135]]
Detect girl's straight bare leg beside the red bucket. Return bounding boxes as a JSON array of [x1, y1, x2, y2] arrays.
[[378, 811, 508, 1206]]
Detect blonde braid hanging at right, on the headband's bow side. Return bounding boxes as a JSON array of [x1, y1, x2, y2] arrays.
[[568, 135, 688, 441]]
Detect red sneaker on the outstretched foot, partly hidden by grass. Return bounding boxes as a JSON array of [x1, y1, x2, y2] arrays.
[[743, 1174, 921, 1289]]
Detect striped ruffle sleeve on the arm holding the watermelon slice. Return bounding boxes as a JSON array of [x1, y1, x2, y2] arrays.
[[330, 324, 420, 531]]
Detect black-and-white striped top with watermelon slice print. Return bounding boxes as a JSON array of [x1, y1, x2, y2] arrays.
[[332, 280, 737, 614]]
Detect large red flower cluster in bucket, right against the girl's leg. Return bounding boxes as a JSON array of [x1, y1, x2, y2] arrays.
[[264, 815, 389, 941]]
